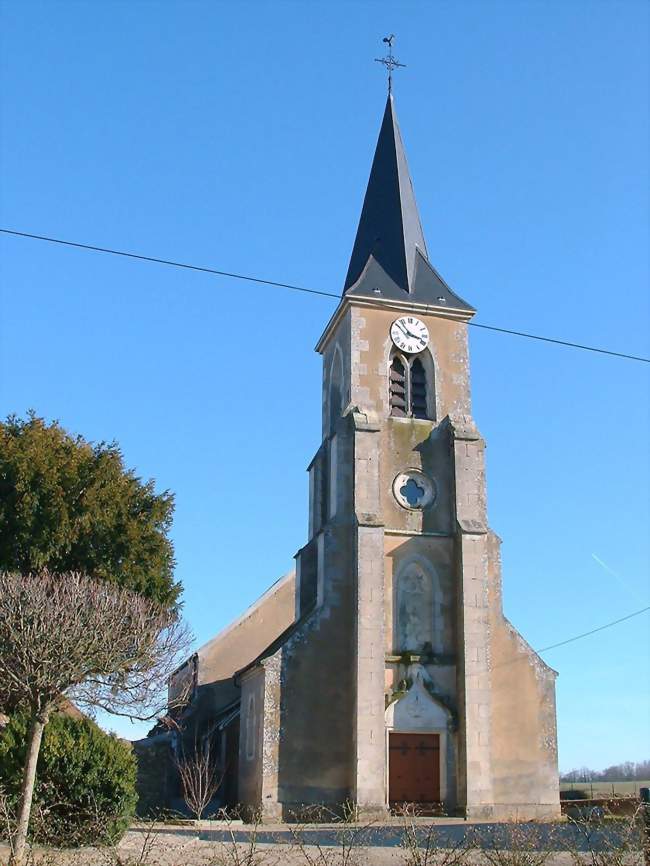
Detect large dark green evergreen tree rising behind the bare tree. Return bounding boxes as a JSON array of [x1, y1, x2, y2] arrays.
[[0, 413, 180, 607]]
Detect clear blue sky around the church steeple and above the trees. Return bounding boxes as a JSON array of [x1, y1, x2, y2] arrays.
[[0, 0, 650, 769]]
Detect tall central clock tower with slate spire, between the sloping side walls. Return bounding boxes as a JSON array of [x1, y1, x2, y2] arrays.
[[317, 95, 492, 809]]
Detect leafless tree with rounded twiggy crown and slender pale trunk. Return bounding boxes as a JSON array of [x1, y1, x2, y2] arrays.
[[0, 572, 190, 866]]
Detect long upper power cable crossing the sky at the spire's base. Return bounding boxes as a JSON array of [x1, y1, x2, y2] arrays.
[[0, 228, 650, 364]]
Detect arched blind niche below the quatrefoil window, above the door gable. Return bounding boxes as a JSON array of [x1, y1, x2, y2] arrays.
[[396, 563, 433, 652]]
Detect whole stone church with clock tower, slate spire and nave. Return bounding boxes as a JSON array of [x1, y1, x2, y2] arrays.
[[136, 95, 559, 820]]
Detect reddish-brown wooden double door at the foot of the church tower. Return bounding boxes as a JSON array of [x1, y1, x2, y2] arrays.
[[388, 732, 440, 803]]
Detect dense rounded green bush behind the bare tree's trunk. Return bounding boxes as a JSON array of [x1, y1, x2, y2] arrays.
[[0, 713, 137, 847]]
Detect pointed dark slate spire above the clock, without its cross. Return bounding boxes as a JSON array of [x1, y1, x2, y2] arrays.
[[343, 93, 473, 310]]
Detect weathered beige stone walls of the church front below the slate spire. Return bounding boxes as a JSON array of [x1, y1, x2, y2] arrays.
[[232, 299, 559, 819]]
